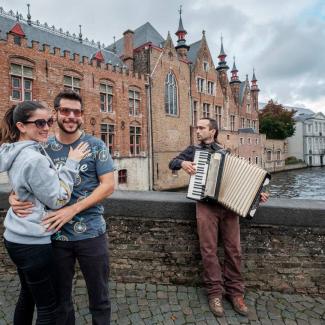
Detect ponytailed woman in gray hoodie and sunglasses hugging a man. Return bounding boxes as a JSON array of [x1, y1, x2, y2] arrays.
[[0, 101, 89, 325]]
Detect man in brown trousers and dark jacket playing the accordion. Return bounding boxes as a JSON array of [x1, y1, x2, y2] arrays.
[[169, 118, 268, 317]]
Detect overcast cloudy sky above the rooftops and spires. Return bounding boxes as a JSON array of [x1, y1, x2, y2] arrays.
[[0, 0, 325, 113]]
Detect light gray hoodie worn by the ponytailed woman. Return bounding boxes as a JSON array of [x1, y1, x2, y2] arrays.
[[0, 141, 79, 244]]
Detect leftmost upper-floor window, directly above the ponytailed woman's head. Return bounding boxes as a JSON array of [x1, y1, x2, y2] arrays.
[[10, 64, 33, 101]]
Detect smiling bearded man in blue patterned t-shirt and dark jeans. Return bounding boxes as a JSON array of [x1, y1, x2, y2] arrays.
[[10, 90, 114, 325]]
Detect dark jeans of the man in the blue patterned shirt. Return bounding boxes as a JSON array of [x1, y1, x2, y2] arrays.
[[52, 234, 111, 325]]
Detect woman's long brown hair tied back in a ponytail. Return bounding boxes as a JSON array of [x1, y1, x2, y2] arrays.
[[0, 100, 45, 144]]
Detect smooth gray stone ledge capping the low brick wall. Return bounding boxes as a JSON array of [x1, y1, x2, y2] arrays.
[[0, 187, 325, 227]]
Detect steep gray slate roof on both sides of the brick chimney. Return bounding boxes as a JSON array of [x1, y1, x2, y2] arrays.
[[106, 22, 165, 56]]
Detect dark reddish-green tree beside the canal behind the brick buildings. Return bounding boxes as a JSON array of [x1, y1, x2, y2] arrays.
[[259, 100, 296, 140]]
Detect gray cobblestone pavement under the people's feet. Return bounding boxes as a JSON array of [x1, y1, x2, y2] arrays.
[[0, 274, 325, 325]]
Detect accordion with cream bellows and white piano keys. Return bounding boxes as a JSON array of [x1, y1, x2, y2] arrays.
[[187, 150, 271, 218]]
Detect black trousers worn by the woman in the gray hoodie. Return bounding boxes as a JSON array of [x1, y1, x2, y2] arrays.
[[4, 240, 56, 325]]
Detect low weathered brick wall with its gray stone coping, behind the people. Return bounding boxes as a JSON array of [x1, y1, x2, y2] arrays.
[[0, 192, 325, 295]]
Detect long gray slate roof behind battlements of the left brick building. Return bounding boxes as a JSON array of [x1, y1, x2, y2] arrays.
[[0, 11, 124, 67]]
